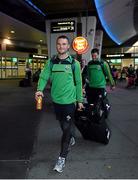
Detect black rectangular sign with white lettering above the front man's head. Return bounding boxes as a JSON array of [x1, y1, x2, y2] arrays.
[[51, 21, 75, 33]]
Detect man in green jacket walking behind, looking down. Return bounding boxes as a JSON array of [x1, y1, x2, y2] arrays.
[[86, 48, 115, 104]]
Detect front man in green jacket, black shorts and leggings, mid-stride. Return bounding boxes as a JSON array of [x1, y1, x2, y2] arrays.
[[35, 36, 83, 172]]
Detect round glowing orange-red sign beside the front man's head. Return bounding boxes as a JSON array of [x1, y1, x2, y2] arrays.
[[72, 36, 89, 54]]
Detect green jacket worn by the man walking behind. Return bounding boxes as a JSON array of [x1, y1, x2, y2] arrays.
[[88, 60, 115, 88]]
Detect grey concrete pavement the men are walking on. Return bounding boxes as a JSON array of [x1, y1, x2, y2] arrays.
[[0, 81, 138, 179]]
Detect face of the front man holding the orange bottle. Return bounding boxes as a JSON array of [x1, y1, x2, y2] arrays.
[[56, 38, 70, 54]]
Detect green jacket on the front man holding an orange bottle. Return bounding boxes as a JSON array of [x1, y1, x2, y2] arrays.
[[37, 57, 83, 104]]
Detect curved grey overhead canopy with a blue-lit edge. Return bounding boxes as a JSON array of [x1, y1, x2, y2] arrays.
[[95, 0, 137, 45]]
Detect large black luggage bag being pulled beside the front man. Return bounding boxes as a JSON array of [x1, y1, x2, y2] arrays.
[[75, 104, 111, 144]]
